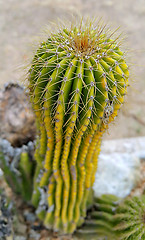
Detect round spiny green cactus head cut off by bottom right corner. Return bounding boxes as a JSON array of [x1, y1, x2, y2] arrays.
[[114, 195, 145, 240]]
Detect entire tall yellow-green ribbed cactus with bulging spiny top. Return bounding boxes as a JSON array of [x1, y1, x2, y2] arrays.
[[28, 21, 129, 233]]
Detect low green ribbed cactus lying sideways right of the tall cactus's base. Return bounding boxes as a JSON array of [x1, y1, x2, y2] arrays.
[[80, 195, 145, 240]]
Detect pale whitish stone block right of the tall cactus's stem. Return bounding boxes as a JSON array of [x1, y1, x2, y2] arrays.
[[93, 137, 145, 198]]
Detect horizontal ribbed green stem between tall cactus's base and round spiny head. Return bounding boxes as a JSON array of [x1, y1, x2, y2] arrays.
[[76, 194, 120, 240]]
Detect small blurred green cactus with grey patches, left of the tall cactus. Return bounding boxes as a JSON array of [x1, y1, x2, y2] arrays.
[[0, 138, 35, 201]]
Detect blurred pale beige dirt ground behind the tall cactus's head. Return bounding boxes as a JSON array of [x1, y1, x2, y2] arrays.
[[0, 0, 145, 138]]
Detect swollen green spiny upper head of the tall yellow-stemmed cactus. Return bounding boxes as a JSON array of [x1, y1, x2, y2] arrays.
[[29, 18, 128, 133]]
